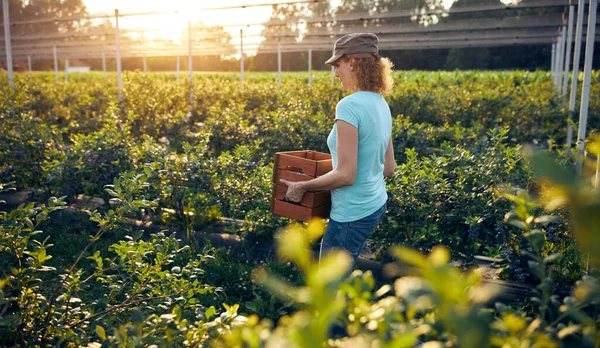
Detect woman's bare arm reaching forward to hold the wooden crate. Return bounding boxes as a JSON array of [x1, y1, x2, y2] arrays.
[[280, 120, 358, 202]]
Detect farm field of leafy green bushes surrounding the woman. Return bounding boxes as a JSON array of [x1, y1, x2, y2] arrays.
[[0, 71, 600, 347]]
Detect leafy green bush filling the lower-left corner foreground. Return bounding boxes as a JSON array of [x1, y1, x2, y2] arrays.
[[0, 173, 224, 346]]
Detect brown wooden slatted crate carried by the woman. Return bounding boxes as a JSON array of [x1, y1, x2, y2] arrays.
[[271, 150, 332, 222]]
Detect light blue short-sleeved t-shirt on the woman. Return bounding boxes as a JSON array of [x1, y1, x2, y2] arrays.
[[327, 91, 392, 222]]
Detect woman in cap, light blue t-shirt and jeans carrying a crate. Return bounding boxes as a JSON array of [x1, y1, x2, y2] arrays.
[[281, 33, 394, 271]]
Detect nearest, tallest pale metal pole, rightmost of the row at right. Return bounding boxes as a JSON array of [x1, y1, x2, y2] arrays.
[[577, 0, 598, 174]]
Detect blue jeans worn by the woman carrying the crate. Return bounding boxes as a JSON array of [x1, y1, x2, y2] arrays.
[[319, 204, 387, 275]]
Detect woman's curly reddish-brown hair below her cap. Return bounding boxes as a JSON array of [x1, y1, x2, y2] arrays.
[[342, 53, 394, 95]]
